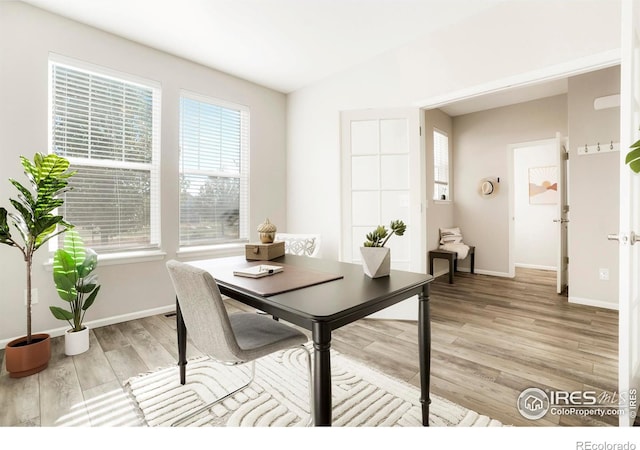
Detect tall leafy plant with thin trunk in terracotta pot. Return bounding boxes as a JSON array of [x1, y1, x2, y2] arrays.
[[0, 153, 75, 378]]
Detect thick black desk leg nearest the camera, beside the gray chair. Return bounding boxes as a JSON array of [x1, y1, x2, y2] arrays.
[[312, 322, 332, 426]]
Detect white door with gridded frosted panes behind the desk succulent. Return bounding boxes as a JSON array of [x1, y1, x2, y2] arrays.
[[341, 108, 426, 320]]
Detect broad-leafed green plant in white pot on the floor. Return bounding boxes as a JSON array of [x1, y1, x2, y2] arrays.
[[49, 230, 100, 356]]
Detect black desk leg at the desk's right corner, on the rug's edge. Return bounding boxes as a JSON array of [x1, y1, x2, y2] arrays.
[[418, 284, 431, 427]]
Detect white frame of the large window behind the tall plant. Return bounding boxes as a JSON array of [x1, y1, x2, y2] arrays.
[[47, 53, 166, 265]]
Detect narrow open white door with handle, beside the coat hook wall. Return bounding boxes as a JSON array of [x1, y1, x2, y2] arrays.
[[554, 133, 569, 294]]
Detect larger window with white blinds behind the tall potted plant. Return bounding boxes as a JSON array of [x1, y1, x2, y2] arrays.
[[50, 58, 160, 253]]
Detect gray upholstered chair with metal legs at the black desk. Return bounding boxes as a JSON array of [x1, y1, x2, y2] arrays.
[[166, 260, 313, 426]]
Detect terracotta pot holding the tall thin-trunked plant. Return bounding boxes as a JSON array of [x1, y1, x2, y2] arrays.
[[4, 333, 51, 378]]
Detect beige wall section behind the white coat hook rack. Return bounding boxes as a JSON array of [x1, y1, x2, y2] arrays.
[[568, 66, 621, 308]]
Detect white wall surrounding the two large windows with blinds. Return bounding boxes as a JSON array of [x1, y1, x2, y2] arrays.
[[0, 2, 286, 344]]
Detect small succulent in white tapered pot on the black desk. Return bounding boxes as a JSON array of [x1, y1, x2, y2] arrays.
[[360, 220, 407, 278]]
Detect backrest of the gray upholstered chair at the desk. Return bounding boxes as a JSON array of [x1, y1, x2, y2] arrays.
[[166, 260, 242, 363]]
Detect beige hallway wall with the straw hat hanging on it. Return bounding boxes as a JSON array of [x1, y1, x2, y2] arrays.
[[453, 95, 567, 276]]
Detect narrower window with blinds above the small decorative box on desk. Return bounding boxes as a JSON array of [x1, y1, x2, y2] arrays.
[[180, 92, 249, 247]]
